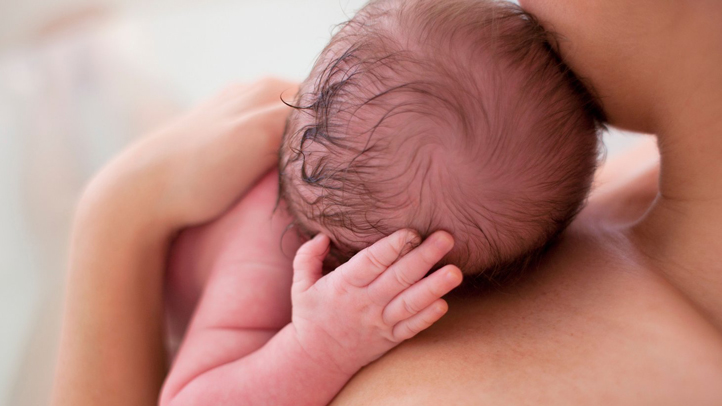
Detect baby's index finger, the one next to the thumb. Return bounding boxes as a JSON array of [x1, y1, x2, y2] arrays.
[[338, 229, 421, 287]]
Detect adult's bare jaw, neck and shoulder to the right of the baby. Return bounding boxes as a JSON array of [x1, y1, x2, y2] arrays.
[[324, 0, 722, 405]]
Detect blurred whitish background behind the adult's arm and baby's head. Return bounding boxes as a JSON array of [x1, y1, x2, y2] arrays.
[[0, 0, 637, 406]]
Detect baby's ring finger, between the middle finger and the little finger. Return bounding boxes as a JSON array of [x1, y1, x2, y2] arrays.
[[383, 265, 462, 326]]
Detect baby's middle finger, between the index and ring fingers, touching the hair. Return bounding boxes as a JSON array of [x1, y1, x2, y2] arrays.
[[369, 231, 454, 303]]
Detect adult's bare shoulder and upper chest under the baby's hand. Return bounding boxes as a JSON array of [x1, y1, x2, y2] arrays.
[[334, 228, 722, 405]]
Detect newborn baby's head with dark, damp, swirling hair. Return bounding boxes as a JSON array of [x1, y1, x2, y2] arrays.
[[280, 0, 599, 277]]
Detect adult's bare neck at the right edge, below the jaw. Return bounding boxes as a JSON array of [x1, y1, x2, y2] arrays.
[[632, 8, 722, 329]]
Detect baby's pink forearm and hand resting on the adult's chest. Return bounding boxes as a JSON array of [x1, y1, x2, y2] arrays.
[[161, 230, 461, 405]]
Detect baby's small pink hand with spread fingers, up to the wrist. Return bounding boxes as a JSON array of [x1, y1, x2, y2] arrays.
[[291, 230, 462, 375]]
